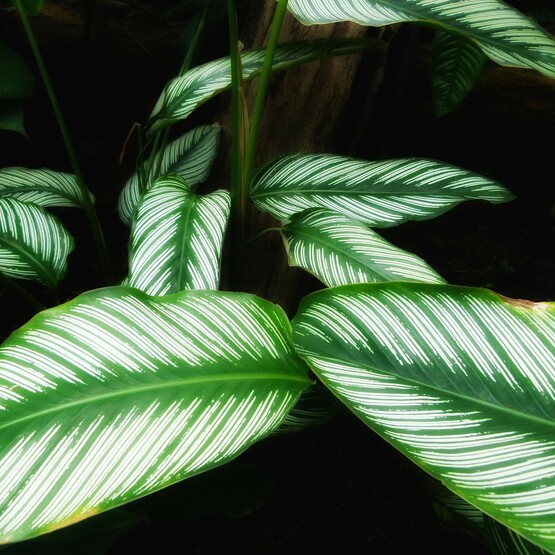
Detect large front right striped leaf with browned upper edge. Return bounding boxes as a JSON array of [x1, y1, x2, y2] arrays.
[[293, 283, 555, 552]]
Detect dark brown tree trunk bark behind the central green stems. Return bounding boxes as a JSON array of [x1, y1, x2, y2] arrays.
[[224, 0, 390, 313]]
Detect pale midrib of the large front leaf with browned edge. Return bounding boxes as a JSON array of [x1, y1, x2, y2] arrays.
[[308, 351, 555, 428]]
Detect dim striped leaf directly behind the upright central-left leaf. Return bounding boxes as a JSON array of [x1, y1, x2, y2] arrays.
[[118, 125, 220, 226]]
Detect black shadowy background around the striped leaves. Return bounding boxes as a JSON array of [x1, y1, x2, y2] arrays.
[[0, 1, 555, 555]]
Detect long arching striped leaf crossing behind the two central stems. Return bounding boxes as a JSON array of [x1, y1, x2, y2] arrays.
[[149, 39, 383, 131]]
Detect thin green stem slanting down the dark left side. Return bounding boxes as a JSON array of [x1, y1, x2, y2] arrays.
[[14, 0, 114, 283]]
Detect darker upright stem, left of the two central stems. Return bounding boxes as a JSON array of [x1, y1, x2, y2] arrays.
[[227, 0, 247, 290]]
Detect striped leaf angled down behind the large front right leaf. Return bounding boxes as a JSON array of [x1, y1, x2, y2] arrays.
[[281, 208, 445, 287]]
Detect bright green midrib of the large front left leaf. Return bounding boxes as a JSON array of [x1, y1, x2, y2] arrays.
[[0, 372, 311, 432]]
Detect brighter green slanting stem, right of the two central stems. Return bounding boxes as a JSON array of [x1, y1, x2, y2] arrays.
[[243, 0, 288, 191]]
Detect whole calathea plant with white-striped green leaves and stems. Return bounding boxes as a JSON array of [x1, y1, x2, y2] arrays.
[[0, 0, 555, 553]]
